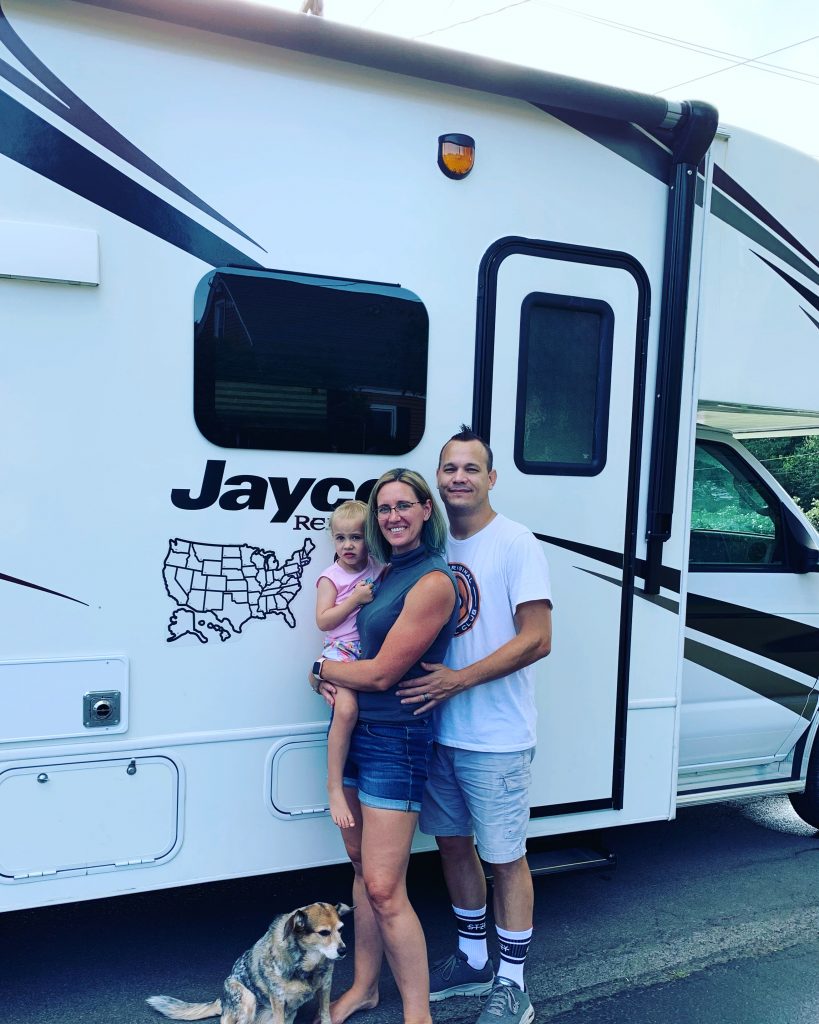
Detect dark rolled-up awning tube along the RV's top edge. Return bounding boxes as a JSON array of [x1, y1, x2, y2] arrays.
[[80, 0, 686, 131]]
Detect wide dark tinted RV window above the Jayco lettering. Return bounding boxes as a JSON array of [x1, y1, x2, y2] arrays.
[[193, 267, 429, 455]]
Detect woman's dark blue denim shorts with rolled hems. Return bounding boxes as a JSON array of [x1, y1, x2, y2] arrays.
[[344, 719, 432, 813]]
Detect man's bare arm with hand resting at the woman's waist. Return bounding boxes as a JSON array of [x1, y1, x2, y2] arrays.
[[396, 601, 552, 715]]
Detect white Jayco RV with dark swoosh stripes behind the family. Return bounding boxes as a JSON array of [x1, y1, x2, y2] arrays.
[[0, 0, 819, 909]]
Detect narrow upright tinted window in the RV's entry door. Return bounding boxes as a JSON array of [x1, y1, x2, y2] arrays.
[[515, 293, 614, 476]]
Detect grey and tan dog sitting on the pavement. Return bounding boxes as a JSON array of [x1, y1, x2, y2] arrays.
[[145, 903, 352, 1024]]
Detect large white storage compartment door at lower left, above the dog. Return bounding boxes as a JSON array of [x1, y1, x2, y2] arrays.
[[0, 757, 181, 881]]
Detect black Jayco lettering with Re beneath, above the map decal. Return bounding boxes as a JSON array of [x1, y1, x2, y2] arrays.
[[171, 459, 375, 529]]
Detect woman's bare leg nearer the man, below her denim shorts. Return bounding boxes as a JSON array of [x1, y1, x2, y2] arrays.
[[356, 805, 432, 1024]]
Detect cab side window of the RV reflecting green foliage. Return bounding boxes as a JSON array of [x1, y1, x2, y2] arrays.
[[689, 441, 784, 569]]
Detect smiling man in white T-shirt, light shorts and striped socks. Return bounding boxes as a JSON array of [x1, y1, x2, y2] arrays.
[[399, 427, 552, 1024]]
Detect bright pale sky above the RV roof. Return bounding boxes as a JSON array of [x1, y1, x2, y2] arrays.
[[267, 0, 819, 159]]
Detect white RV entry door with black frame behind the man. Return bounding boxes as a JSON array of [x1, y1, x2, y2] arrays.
[[474, 239, 648, 817]]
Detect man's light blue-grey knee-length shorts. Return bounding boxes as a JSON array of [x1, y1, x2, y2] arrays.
[[419, 743, 534, 864]]
